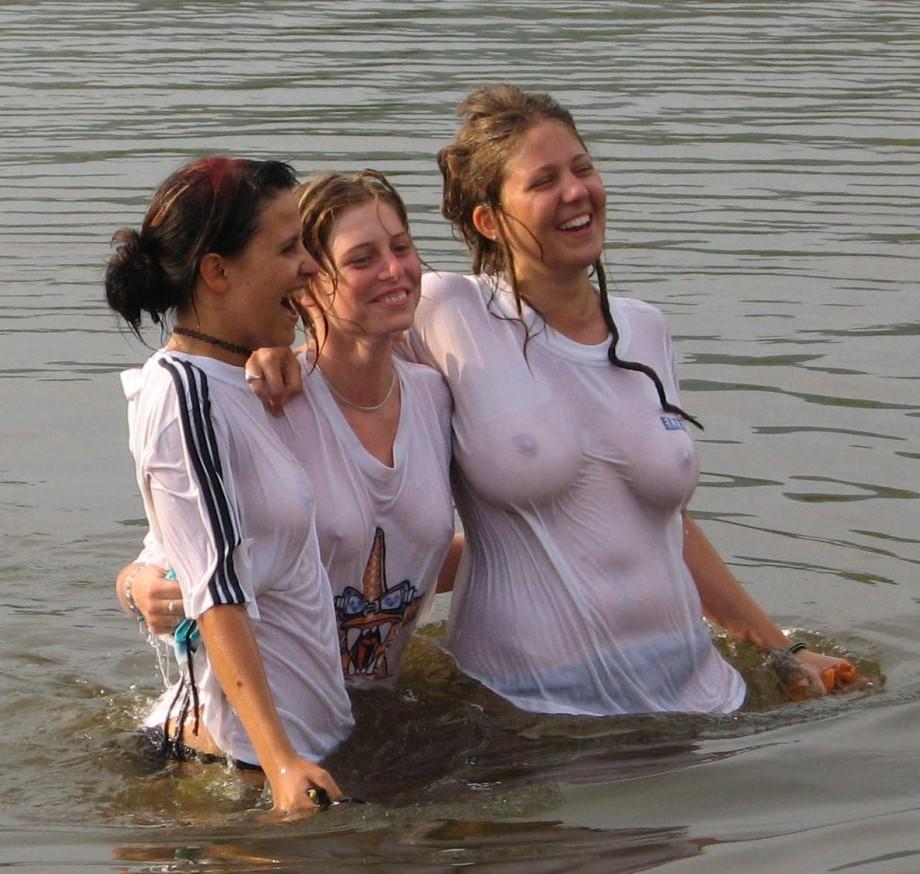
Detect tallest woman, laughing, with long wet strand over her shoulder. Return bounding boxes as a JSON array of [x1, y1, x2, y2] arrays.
[[409, 85, 856, 716]]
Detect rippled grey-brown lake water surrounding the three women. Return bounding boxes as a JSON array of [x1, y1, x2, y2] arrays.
[[0, 0, 920, 874]]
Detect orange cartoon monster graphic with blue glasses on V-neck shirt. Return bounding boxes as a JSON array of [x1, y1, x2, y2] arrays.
[[335, 528, 420, 680]]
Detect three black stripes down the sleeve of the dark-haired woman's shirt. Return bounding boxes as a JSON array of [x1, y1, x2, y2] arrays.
[[160, 358, 246, 604]]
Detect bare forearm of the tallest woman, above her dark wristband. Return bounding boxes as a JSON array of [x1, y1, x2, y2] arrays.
[[683, 510, 791, 649]]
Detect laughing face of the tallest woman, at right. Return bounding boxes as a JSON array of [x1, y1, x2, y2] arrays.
[[498, 119, 607, 281]]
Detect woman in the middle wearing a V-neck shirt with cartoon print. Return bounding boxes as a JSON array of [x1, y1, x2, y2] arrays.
[[120, 171, 453, 683]]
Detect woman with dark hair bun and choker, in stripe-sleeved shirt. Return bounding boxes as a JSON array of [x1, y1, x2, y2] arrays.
[[105, 157, 352, 813]]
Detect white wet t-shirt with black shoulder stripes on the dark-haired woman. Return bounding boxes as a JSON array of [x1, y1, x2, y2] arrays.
[[122, 351, 353, 764]]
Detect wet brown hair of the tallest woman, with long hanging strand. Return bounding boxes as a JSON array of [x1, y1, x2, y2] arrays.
[[438, 84, 702, 428]]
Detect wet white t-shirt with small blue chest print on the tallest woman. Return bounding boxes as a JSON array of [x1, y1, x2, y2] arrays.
[[409, 274, 745, 715]]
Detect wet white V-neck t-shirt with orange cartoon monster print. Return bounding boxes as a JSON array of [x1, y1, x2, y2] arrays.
[[273, 355, 454, 682]]
